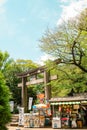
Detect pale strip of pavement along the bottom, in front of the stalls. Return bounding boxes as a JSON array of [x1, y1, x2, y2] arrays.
[[8, 126, 87, 130]]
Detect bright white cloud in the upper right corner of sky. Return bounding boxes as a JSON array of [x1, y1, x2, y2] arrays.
[[57, 0, 87, 25]]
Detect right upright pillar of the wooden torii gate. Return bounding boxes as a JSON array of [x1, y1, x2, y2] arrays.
[[44, 71, 51, 100]]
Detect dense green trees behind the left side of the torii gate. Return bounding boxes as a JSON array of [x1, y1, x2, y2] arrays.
[[0, 51, 38, 110]]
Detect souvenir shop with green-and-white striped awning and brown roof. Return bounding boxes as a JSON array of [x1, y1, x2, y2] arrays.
[[50, 94, 87, 128]]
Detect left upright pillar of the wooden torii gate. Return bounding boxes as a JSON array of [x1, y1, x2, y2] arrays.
[[22, 77, 27, 112]]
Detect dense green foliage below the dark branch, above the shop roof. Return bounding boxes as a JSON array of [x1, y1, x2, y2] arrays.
[[46, 61, 87, 97]]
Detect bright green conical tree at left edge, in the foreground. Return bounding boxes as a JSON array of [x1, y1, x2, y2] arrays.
[[0, 72, 11, 130]]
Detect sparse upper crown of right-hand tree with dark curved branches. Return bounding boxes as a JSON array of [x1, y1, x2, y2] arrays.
[[40, 10, 87, 72]]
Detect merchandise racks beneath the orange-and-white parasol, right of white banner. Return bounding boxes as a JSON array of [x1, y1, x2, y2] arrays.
[[24, 104, 50, 128]]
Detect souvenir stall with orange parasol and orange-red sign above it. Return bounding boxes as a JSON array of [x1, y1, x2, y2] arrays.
[[19, 94, 51, 128]]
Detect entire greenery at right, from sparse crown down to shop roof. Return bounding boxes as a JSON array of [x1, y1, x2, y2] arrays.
[[40, 9, 87, 96]]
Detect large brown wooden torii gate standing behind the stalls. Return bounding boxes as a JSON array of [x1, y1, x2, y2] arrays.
[[17, 59, 60, 112]]
